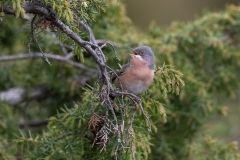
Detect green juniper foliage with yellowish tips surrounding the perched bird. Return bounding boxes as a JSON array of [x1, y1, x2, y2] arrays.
[[0, 0, 240, 160]]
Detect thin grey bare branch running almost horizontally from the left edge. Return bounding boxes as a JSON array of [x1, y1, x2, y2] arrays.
[[0, 53, 97, 73]]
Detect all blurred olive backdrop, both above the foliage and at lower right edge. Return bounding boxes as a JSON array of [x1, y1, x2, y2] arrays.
[[126, 0, 240, 143]]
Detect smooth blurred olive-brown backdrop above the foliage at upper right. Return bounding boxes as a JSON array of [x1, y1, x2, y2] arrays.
[[126, 0, 240, 30]]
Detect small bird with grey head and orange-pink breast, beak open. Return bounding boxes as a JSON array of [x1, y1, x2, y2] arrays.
[[111, 46, 155, 95]]
